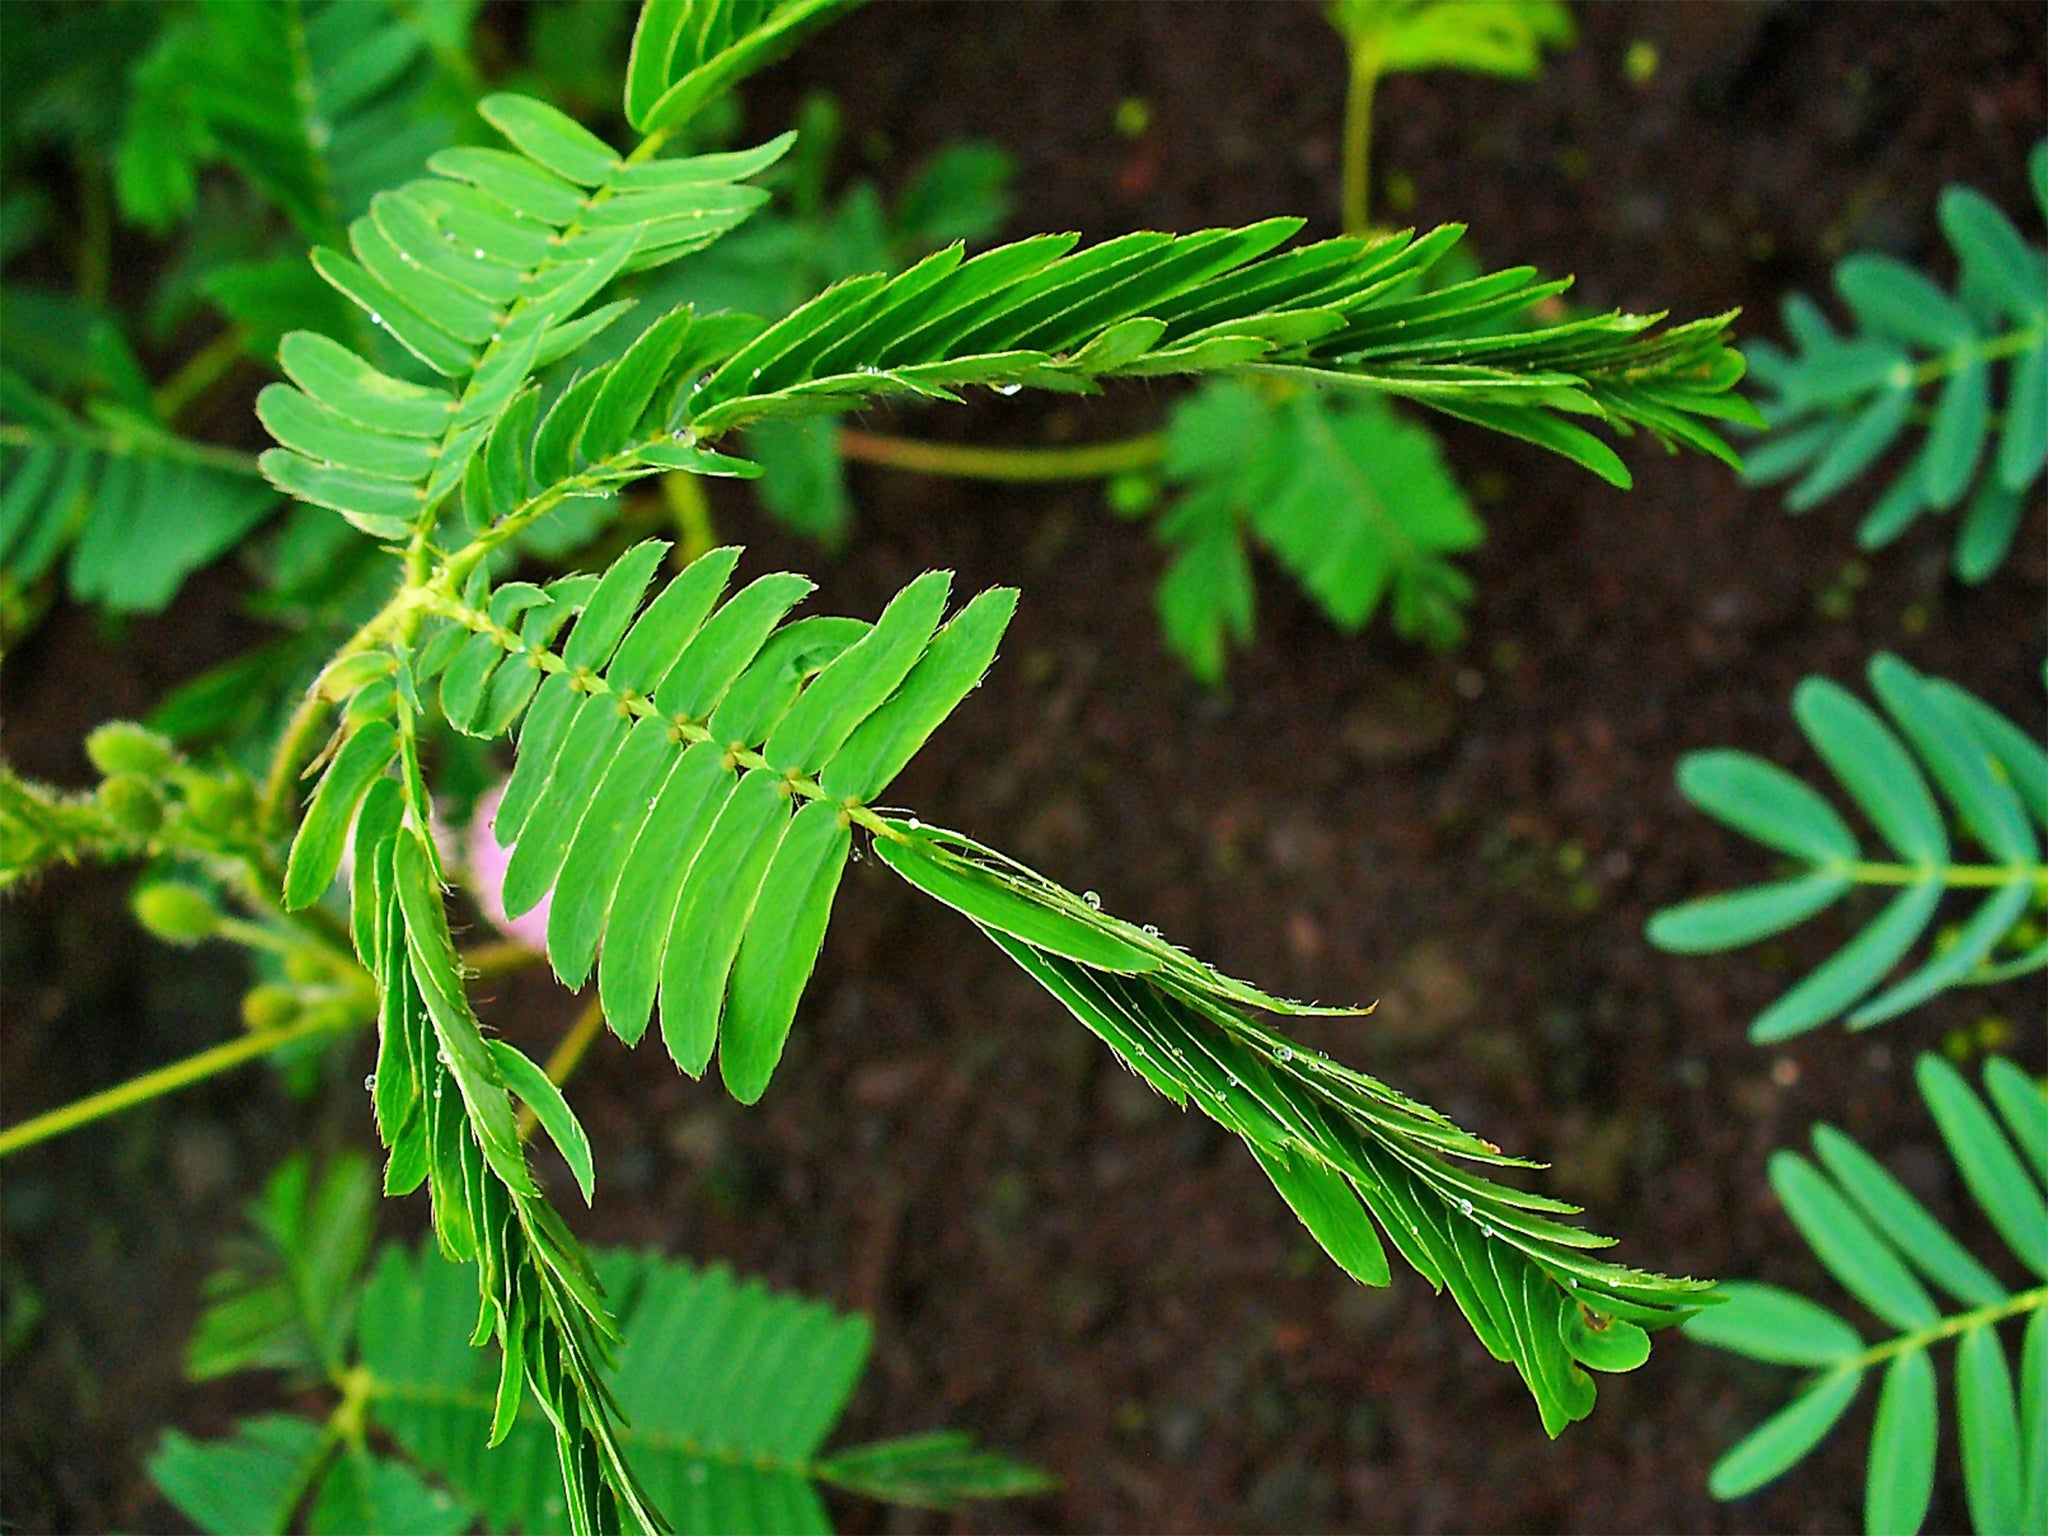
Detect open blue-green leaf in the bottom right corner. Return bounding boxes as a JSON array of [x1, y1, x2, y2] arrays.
[[1686, 1057, 2048, 1536]]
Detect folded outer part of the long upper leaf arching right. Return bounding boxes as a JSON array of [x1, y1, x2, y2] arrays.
[[678, 219, 1751, 473]]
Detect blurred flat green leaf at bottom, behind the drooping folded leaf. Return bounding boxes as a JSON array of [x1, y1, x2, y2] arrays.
[[362, 1247, 1047, 1536]]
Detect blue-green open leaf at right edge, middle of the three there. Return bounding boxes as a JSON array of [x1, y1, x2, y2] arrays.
[[1649, 655, 2048, 1040]]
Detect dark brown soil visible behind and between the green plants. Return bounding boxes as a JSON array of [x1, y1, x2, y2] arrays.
[[0, 4, 2048, 1532]]
